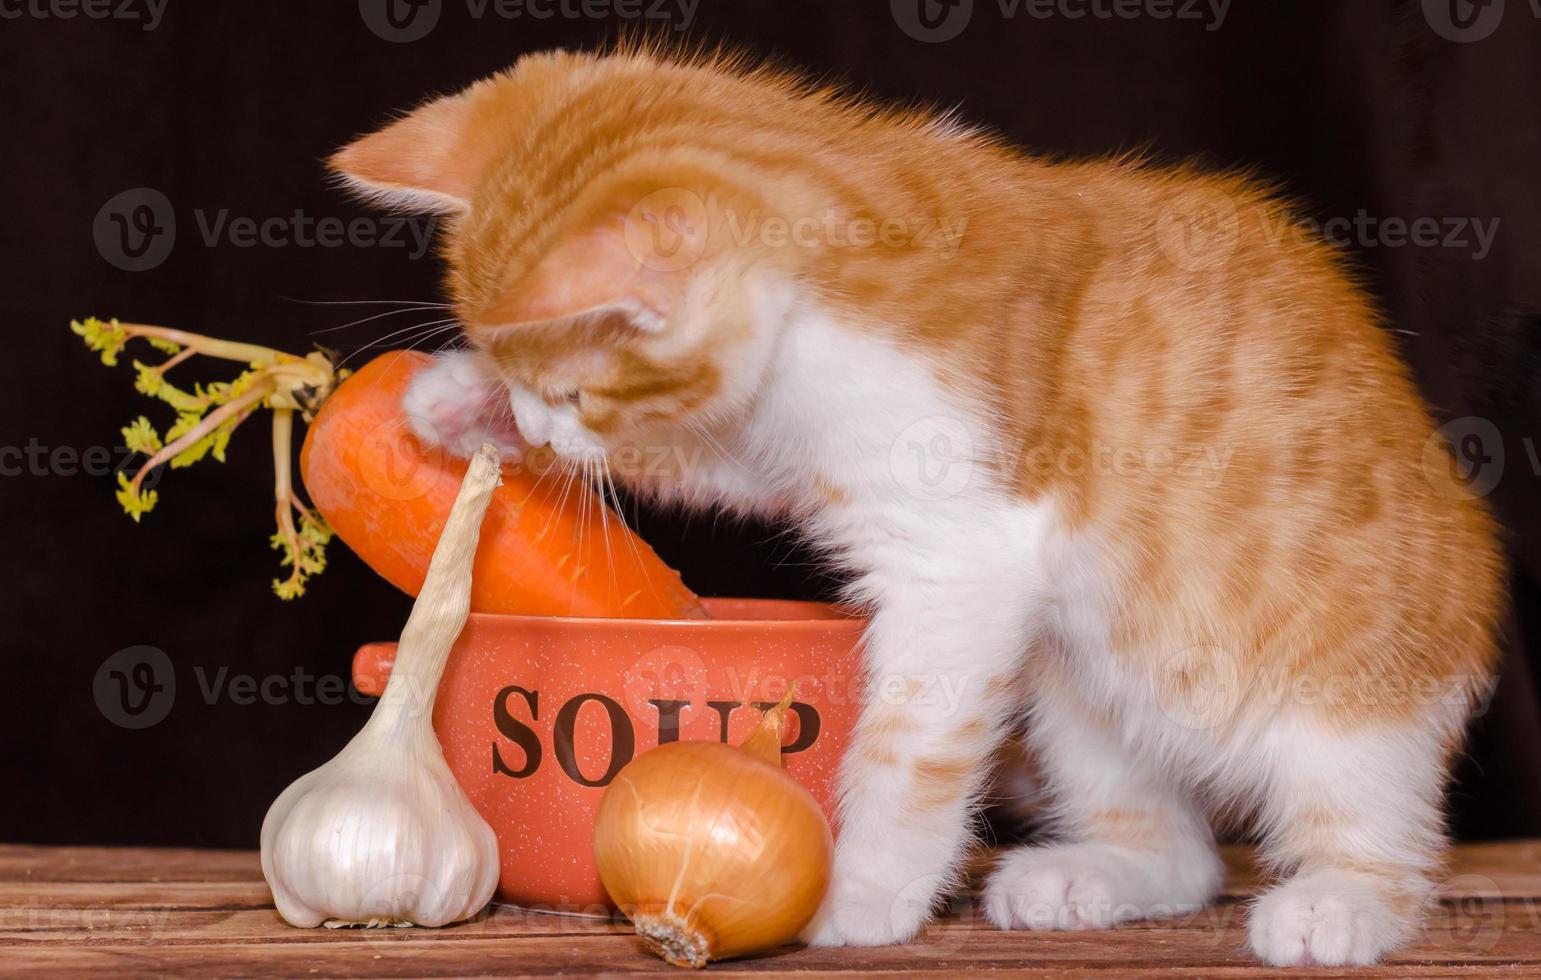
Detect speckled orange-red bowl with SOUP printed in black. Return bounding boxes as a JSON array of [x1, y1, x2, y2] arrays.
[[353, 599, 865, 914]]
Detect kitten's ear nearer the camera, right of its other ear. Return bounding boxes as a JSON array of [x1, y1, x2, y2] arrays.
[[479, 188, 710, 333]]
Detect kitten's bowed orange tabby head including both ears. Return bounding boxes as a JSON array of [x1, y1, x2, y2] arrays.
[[331, 52, 795, 451]]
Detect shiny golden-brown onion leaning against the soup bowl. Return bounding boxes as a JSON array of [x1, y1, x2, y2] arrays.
[[593, 692, 834, 969]]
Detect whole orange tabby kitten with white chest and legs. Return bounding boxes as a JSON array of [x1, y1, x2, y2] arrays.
[[333, 49, 1501, 965]]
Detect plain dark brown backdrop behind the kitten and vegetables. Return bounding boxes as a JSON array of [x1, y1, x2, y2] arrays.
[[0, 0, 1541, 846]]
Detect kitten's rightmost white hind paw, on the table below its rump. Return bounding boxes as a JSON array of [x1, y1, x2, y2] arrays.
[[1248, 872, 1416, 966]]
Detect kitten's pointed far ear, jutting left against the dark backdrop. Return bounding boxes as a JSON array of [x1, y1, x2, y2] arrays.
[[328, 88, 499, 211]]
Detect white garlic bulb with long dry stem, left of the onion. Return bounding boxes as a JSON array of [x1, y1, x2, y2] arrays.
[[262, 445, 498, 928]]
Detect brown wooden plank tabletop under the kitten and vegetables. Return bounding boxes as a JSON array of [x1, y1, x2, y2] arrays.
[[0, 841, 1541, 978]]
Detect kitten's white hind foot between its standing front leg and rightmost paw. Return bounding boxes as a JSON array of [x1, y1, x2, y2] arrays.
[[985, 843, 1220, 931]]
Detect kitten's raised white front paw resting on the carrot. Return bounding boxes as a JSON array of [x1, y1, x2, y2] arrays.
[[401, 351, 524, 456]]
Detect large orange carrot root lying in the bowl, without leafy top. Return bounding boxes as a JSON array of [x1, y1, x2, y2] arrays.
[[300, 351, 706, 618]]
